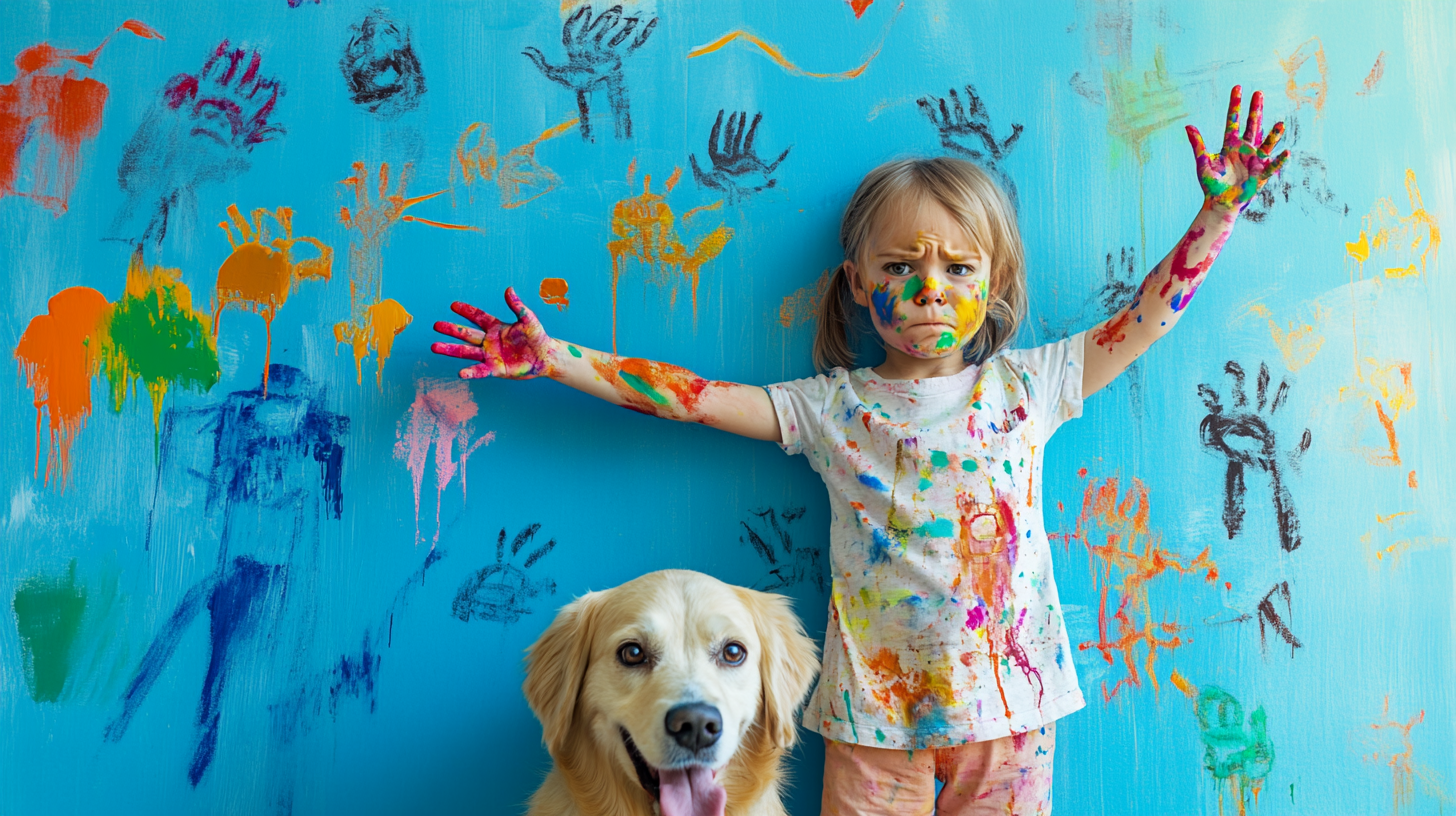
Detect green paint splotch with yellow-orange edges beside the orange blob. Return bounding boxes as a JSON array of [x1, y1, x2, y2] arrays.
[[102, 248, 221, 428]]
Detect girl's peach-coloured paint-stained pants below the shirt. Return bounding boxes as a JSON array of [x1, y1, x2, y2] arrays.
[[821, 723, 1057, 816]]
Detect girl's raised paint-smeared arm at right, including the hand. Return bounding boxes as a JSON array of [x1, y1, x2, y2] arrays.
[[1082, 86, 1289, 396]]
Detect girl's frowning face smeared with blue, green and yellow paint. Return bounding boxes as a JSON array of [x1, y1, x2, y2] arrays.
[[844, 198, 992, 358]]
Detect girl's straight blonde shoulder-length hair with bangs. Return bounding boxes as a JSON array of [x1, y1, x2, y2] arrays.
[[814, 156, 1026, 370]]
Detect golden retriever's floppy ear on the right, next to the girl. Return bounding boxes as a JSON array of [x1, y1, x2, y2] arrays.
[[737, 587, 820, 749]]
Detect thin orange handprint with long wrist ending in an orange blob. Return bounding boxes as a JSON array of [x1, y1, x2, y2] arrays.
[[333, 162, 475, 388]]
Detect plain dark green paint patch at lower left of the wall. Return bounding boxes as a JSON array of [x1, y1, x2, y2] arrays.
[[10, 561, 86, 702]]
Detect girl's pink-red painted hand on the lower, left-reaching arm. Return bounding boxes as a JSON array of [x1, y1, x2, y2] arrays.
[[430, 289, 555, 380]]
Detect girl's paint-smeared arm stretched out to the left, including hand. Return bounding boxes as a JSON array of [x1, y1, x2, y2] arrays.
[[430, 289, 780, 442]]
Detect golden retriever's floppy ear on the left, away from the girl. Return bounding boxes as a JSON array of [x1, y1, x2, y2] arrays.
[[521, 592, 606, 756]]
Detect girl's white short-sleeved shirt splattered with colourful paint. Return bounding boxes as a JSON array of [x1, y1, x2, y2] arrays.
[[769, 335, 1083, 749]]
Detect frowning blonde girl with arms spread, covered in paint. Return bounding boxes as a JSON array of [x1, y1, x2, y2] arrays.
[[432, 87, 1289, 815]]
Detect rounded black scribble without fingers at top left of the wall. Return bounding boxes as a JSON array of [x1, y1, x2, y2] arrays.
[[339, 9, 425, 119]]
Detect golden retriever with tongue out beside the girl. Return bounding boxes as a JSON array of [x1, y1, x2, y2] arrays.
[[524, 570, 818, 816]]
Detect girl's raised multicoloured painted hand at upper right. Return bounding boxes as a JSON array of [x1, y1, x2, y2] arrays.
[[1188, 85, 1289, 213]]
